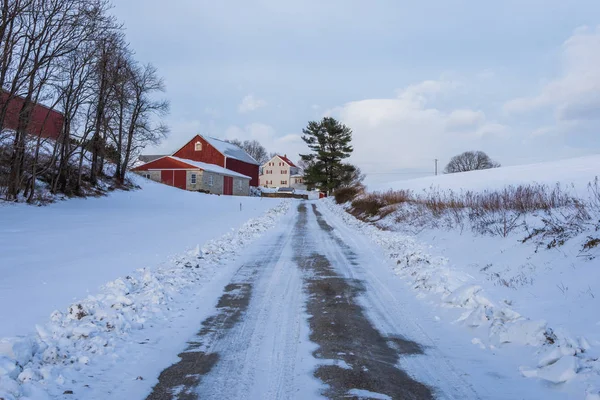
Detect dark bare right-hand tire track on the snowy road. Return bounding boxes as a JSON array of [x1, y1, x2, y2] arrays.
[[294, 204, 433, 399]]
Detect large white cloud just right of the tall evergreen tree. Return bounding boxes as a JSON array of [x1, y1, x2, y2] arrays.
[[330, 81, 507, 173]]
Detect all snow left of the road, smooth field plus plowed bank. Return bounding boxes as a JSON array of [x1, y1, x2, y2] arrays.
[[0, 182, 289, 400]]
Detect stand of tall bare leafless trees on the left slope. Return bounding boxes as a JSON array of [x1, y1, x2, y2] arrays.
[[0, 0, 169, 201]]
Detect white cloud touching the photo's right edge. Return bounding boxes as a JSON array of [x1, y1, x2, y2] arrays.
[[504, 27, 600, 120]]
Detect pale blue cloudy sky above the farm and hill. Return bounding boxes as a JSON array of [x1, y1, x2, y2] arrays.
[[114, 0, 600, 185]]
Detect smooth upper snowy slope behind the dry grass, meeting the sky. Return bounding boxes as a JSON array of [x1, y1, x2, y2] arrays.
[[378, 155, 600, 195]]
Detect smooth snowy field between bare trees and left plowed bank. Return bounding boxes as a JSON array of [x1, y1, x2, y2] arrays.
[[0, 178, 278, 337]]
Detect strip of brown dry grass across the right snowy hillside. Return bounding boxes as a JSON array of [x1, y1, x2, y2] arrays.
[[344, 179, 600, 245]]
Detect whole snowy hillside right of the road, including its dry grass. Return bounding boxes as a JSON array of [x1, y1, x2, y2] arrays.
[[334, 156, 600, 399]]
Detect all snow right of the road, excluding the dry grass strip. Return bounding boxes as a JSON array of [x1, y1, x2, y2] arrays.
[[328, 156, 600, 399]]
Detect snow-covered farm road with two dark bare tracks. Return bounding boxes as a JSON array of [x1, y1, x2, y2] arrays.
[[142, 202, 565, 400]]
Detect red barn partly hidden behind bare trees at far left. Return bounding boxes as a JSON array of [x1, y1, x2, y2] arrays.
[[0, 91, 65, 140]]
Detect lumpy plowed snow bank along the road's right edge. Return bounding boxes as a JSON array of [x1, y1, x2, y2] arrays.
[[325, 199, 600, 399]]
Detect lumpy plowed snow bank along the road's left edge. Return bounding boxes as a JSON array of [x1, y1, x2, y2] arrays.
[[0, 202, 290, 400]]
